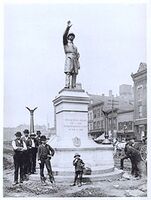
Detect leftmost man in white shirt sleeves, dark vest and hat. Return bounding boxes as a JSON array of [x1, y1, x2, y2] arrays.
[[12, 132, 27, 185]]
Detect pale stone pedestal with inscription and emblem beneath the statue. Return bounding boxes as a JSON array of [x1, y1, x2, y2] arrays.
[[49, 89, 122, 180]]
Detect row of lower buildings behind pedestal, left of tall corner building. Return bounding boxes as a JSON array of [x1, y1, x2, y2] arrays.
[[88, 89, 134, 141]]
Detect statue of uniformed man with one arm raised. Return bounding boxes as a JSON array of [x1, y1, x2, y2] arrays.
[[63, 21, 80, 88]]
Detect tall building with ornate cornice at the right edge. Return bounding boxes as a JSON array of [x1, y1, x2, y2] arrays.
[[131, 63, 147, 140]]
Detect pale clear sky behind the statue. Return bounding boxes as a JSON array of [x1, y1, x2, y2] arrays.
[[4, 4, 146, 127]]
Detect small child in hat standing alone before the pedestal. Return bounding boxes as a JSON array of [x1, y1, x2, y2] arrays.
[[71, 153, 85, 187]]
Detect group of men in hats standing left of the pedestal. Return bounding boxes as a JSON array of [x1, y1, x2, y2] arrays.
[[12, 129, 55, 185]]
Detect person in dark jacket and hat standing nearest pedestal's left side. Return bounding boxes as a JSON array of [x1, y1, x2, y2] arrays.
[[38, 135, 55, 184]]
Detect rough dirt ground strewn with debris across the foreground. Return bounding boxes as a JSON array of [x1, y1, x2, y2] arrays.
[[3, 141, 147, 197]]
